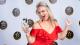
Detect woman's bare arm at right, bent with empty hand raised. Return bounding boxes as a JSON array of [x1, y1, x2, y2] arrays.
[[55, 20, 71, 40]]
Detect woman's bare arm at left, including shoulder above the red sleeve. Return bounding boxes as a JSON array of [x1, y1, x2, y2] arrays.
[[23, 22, 40, 43]]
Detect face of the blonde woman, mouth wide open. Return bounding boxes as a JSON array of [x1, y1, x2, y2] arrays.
[[37, 6, 49, 20]]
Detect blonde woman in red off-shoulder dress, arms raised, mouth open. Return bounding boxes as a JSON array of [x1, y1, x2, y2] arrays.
[[23, 2, 70, 45]]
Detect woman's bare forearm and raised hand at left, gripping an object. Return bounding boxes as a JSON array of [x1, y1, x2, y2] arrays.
[[22, 24, 35, 43]]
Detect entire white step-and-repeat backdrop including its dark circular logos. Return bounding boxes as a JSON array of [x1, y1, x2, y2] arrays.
[[0, 0, 80, 45]]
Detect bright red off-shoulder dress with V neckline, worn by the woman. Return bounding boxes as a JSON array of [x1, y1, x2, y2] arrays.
[[29, 26, 62, 45]]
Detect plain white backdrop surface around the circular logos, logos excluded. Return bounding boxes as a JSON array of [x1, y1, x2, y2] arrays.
[[0, 0, 80, 45]]
